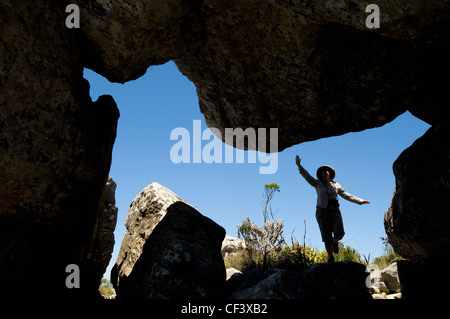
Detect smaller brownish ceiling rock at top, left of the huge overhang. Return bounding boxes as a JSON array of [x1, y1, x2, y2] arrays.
[[76, 0, 204, 83]]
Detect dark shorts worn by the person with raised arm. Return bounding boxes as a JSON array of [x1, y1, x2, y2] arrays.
[[316, 207, 345, 242]]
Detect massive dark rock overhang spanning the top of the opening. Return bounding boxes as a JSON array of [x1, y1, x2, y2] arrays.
[[74, 0, 449, 150]]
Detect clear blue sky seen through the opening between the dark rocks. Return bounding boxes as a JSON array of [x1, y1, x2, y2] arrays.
[[84, 62, 429, 278]]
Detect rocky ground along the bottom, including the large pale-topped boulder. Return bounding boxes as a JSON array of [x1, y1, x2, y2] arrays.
[[111, 183, 401, 299]]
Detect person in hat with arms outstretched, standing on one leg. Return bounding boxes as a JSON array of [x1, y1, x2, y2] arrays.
[[295, 155, 370, 262]]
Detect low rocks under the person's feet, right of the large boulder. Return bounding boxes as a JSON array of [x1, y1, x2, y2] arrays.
[[222, 235, 402, 299]]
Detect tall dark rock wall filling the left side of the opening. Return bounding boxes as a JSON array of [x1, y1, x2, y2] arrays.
[[0, 0, 119, 298]]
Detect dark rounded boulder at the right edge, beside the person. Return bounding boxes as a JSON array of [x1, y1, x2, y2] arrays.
[[384, 125, 450, 262]]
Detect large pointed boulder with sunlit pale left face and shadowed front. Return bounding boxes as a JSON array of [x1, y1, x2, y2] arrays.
[[111, 183, 226, 299]]
